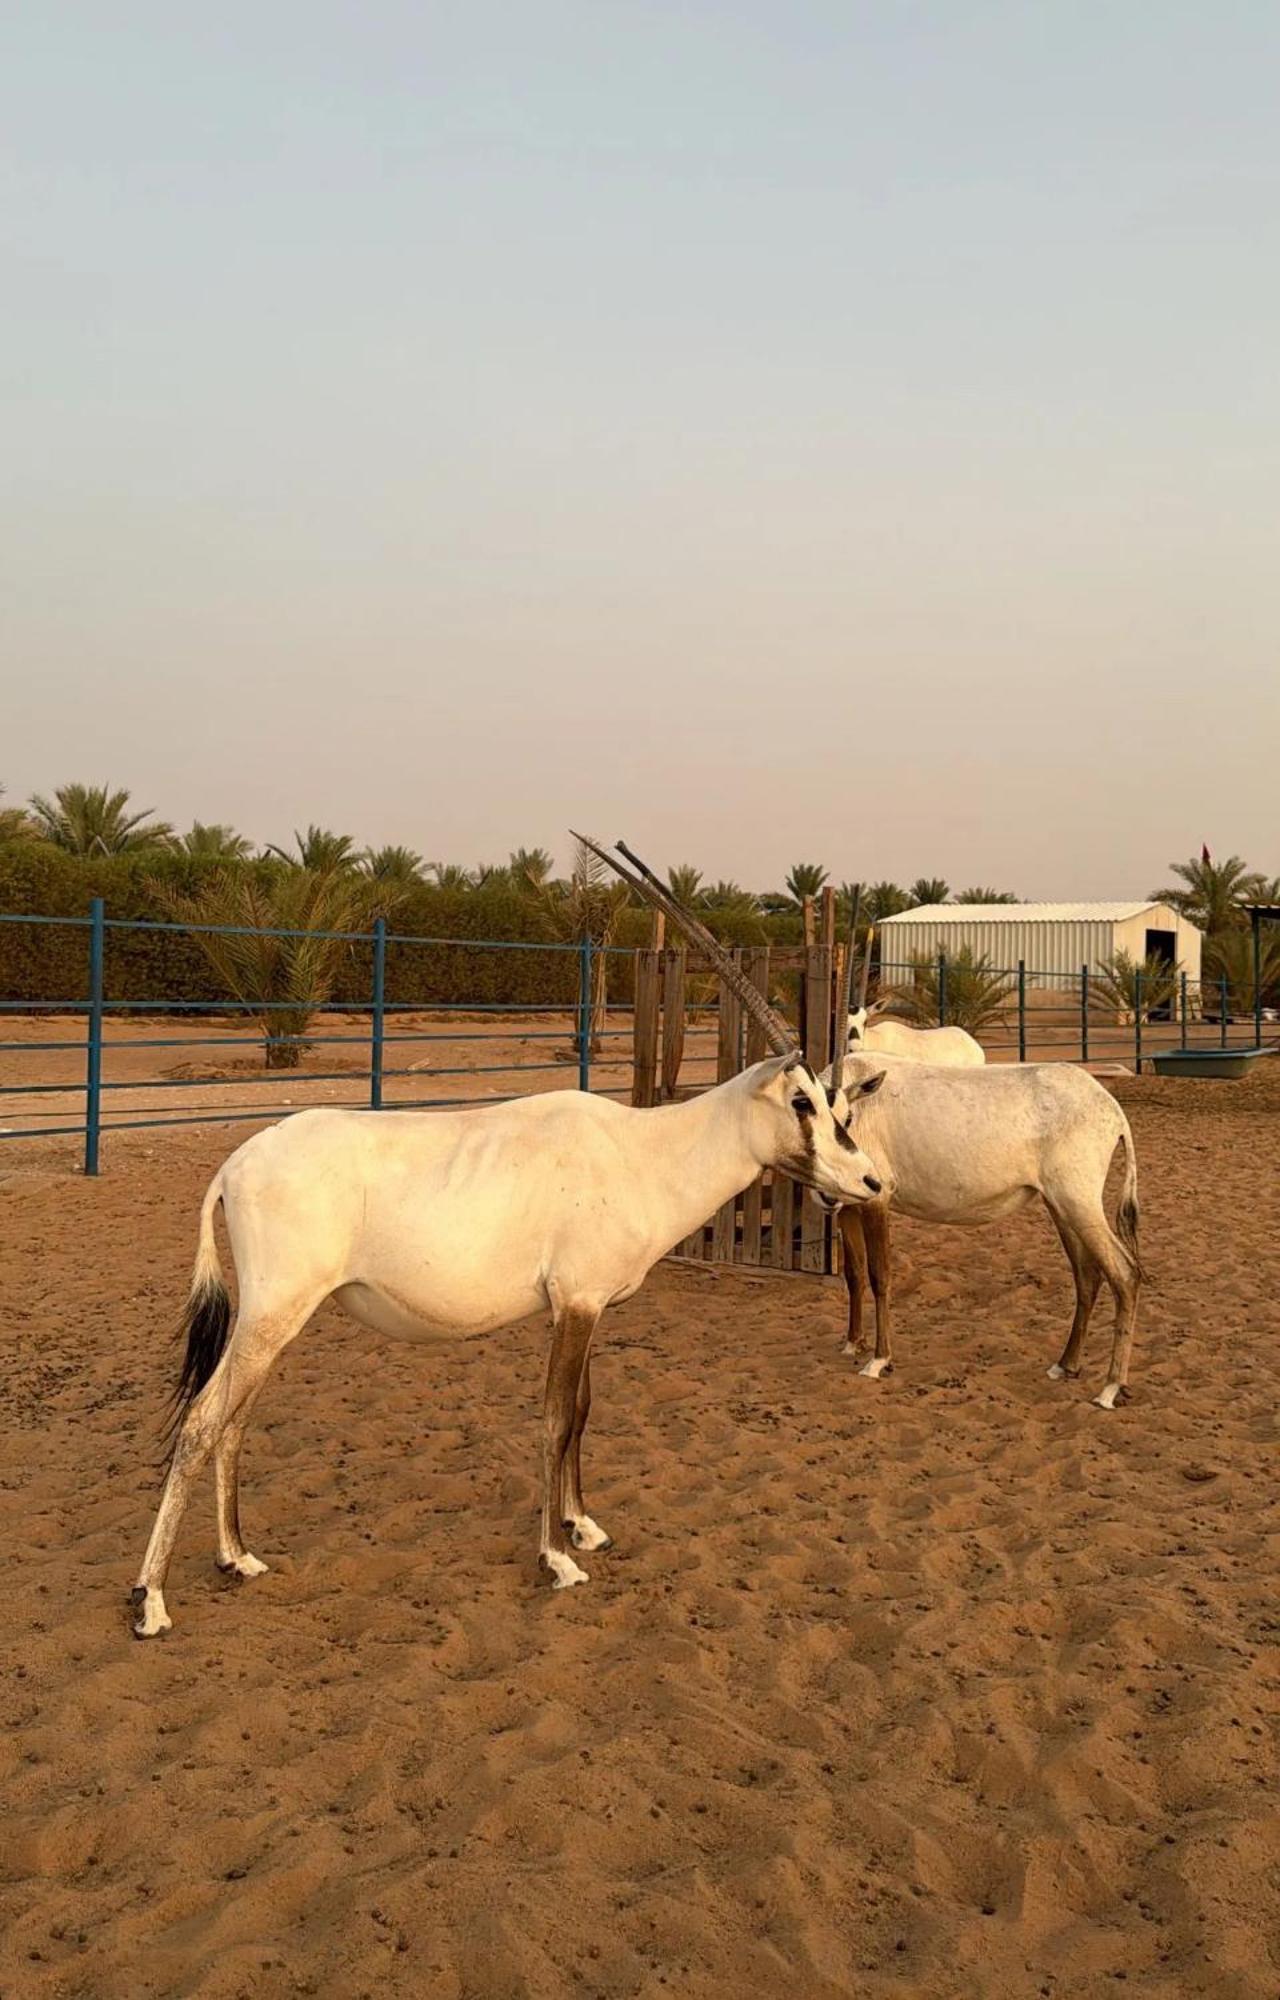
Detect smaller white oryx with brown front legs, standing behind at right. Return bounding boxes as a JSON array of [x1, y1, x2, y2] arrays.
[[842, 1054, 1142, 1410]]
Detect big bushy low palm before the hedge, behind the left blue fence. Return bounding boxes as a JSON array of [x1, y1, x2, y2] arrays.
[[152, 866, 384, 1070]]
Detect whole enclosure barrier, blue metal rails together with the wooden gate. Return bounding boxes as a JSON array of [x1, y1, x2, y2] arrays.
[[0, 916, 1274, 1208]]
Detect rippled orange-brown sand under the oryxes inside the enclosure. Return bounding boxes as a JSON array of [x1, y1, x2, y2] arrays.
[[0, 1078, 1280, 2000]]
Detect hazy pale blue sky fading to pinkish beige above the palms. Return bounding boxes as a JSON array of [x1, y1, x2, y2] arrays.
[[0, 0, 1280, 896]]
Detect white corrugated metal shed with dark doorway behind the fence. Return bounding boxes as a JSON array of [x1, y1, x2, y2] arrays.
[[880, 900, 1202, 988]]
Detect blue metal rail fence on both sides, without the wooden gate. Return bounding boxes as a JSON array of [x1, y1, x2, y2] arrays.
[[0, 916, 1268, 1174]]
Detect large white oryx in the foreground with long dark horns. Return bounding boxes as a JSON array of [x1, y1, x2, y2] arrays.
[[134, 842, 880, 1638]]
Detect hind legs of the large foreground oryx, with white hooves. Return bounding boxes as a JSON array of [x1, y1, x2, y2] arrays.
[[134, 1292, 326, 1638]]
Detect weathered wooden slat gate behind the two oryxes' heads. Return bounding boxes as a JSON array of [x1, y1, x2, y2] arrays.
[[632, 892, 844, 1274]]
